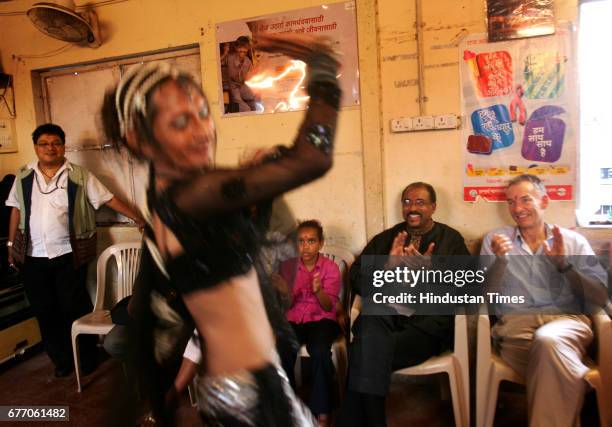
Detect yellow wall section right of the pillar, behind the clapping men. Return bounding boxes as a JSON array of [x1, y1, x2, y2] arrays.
[[378, 0, 577, 247]]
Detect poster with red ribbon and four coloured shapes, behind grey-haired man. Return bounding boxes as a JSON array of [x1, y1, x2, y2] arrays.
[[460, 28, 578, 202]]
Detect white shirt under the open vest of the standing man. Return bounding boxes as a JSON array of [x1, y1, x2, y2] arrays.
[[6, 160, 113, 258]]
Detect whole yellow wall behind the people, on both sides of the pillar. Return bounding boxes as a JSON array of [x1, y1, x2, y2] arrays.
[[0, 0, 596, 252]]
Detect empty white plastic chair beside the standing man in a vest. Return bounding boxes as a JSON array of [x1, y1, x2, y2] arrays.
[[72, 242, 142, 392]]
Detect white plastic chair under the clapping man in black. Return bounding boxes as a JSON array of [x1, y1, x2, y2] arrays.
[[351, 295, 470, 427]]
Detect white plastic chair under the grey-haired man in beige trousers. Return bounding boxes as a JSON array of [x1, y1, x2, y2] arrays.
[[476, 312, 612, 427]]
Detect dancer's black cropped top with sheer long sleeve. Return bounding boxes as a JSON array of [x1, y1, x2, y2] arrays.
[[149, 85, 339, 294]]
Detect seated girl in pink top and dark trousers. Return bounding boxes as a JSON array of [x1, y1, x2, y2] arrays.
[[273, 220, 341, 425]]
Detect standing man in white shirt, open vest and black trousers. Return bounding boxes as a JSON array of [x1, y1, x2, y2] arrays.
[[6, 123, 143, 377]]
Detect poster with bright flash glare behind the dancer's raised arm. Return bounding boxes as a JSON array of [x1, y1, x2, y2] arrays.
[[217, 1, 359, 115]]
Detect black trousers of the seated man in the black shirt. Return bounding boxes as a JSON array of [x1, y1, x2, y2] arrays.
[[338, 315, 454, 427]]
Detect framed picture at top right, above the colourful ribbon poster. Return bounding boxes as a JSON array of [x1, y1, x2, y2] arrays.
[[487, 0, 555, 42]]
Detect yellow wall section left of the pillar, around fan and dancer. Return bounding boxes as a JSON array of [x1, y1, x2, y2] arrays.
[[0, 0, 365, 251]]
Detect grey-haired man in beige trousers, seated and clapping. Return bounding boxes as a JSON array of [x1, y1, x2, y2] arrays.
[[481, 175, 607, 427]]
